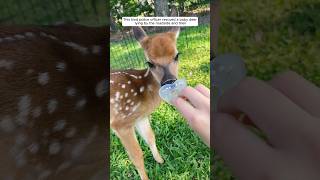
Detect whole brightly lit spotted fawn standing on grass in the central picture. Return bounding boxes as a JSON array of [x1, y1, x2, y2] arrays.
[[110, 27, 180, 180]]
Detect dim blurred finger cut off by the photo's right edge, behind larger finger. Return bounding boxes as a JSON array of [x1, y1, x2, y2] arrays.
[[269, 71, 320, 118]]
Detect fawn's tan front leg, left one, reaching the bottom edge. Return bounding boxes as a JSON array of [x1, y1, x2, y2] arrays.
[[115, 127, 149, 180]]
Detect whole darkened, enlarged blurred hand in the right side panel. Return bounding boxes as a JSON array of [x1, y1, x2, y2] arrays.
[[212, 72, 320, 180]]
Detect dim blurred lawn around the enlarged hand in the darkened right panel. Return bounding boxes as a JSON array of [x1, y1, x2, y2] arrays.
[[213, 0, 320, 180]]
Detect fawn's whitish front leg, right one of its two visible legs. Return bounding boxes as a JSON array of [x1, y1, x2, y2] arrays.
[[136, 117, 163, 164]]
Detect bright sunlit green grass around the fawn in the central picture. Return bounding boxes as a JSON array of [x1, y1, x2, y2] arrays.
[[110, 25, 210, 180]]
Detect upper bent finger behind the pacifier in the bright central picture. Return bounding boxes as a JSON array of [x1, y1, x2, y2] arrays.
[[179, 87, 208, 107]]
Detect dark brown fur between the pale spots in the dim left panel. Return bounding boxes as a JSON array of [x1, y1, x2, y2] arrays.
[[0, 25, 107, 179]]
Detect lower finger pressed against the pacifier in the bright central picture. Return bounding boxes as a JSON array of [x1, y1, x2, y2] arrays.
[[172, 97, 196, 122]]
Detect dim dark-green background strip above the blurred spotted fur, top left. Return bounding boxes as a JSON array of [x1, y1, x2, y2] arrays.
[[0, 0, 108, 26]]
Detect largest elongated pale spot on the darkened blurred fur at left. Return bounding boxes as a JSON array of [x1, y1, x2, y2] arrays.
[[16, 95, 31, 125]]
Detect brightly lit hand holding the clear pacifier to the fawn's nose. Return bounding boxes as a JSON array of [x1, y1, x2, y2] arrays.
[[172, 85, 210, 146]]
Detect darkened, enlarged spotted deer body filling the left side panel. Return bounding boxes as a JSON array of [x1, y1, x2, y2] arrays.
[[0, 25, 108, 180]]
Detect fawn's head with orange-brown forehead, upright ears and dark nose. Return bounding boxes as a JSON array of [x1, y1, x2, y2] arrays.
[[133, 27, 180, 85]]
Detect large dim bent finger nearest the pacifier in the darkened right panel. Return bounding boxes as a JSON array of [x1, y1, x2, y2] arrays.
[[218, 78, 311, 146]]
